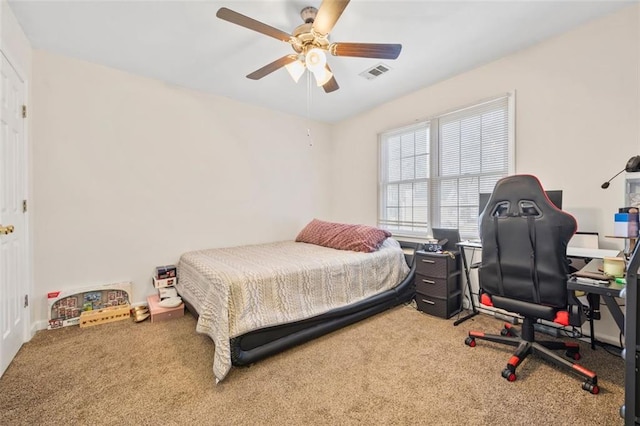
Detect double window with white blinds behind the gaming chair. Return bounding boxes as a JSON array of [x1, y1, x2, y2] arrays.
[[378, 94, 514, 238]]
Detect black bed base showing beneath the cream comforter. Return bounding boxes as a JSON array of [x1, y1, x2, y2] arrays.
[[185, 246, 416, 366]]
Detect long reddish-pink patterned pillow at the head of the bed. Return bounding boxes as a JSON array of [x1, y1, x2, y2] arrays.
[[296, 219, 391, 253]]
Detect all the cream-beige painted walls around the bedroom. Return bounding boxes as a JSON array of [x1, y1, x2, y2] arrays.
[[2, 1, 640, 332]]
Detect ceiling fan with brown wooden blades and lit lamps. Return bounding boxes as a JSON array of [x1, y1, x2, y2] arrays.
[[216, 0, 402, 93]]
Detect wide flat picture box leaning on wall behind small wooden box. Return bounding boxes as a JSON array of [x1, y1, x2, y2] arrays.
[[47, 281, 131, 330]]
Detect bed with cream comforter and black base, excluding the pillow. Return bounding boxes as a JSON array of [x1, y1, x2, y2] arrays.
[[176, 223, 415, 383]]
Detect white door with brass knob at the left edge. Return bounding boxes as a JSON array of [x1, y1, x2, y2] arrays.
[[0, 54, 29, 375]]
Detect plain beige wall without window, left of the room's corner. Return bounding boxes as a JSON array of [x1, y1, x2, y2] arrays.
[[32, 50, 330, 318]]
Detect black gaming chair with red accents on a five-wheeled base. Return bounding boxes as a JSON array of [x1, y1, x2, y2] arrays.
[[465, 175, 599, 394]]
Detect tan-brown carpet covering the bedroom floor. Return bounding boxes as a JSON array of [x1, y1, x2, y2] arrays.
[[0, 305, 624, 425]]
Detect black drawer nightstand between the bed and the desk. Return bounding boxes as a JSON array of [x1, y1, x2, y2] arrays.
[[415, 251, 462, 318]]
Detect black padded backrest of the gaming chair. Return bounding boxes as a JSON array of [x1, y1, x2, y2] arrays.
[[479, 175, 576, 317]]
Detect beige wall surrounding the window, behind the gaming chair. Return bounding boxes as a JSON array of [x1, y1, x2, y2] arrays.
[[331, 6, 640, 247]]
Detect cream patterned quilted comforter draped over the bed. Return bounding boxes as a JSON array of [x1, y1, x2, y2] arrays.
[[176, 238, 409, 383]]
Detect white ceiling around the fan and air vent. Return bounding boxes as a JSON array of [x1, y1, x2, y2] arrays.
[[9, 0, 637, 122]]
